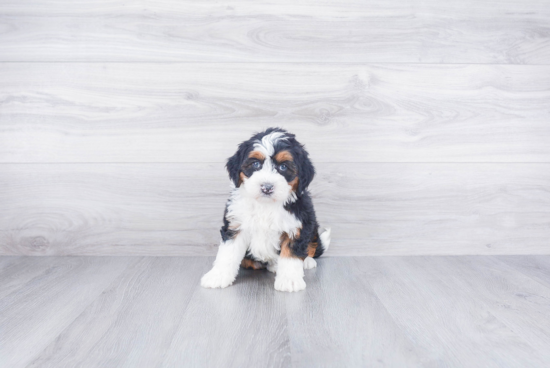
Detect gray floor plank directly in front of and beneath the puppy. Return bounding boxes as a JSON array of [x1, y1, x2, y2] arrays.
[[159, 259, 290, 367]]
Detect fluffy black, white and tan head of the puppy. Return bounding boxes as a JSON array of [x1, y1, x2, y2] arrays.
[[226, 128, 315, 203]]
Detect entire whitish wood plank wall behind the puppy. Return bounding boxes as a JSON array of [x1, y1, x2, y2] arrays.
[[0, 0, 550, 255]]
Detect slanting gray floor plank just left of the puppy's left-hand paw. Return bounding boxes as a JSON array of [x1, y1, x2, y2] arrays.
[[28, 257, 212, 367]]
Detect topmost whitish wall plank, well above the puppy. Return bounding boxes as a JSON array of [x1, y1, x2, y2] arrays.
[[0, 0, 550, 64]]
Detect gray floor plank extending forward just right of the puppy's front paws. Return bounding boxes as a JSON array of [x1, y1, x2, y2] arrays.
[[285, 257, 430, 367]]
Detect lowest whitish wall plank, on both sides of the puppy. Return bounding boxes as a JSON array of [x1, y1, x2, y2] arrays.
[[0, 163, 550, 255]]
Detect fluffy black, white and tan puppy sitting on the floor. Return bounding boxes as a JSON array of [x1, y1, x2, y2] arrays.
[[201, 128, 330, 291]]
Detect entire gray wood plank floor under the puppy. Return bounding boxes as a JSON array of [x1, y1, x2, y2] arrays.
[[0, 256, 550, 368]]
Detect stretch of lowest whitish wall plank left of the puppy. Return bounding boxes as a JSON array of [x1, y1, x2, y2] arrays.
[[0, 164, 229, 255]]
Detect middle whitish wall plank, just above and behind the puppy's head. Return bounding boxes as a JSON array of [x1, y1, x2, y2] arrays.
[[0, 63, 550, 163]]
